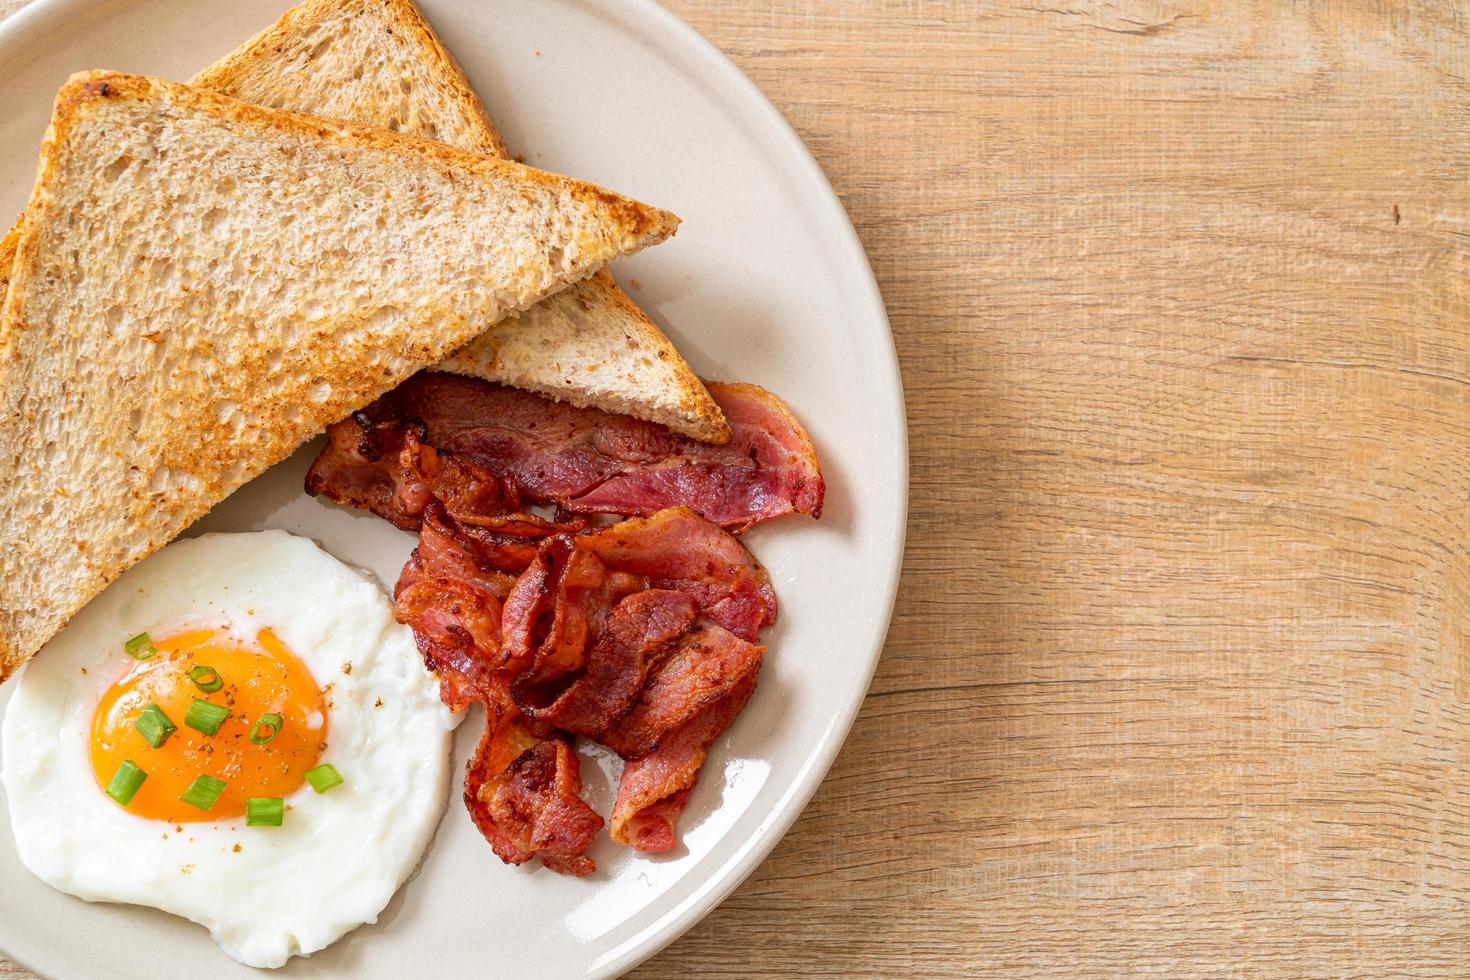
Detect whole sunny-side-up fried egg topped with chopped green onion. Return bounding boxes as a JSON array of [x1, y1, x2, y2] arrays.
[[0, 530, 453, 967]]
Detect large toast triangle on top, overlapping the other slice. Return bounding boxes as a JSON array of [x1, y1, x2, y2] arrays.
[[0, 72, 678, 677]]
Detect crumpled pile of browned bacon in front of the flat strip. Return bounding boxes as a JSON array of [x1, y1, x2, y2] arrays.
[[354, 437, 776, 874]]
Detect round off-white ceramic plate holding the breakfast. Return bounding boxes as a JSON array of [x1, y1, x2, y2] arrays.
[[0, 0, 907, 980]]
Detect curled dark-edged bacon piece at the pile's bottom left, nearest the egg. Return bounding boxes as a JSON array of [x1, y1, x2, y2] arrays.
[[465, 698, 603, 876]]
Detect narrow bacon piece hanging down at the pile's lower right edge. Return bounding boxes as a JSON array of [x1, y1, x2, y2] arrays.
[[610, 664, 760, 851]]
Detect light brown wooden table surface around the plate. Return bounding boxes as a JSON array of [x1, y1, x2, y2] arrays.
[[0, 0, 1470, 980]]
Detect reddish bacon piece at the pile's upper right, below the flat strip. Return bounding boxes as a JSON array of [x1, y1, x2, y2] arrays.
[[576, 507, 776, 642]]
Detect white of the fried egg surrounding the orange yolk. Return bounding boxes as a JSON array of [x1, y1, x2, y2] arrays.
[[0, 530, 453, 967]]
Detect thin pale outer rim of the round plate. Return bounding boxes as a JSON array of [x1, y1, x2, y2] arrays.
[[0, 0, 910, 980]]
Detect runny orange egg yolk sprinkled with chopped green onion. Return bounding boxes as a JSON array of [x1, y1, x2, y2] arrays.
[[91, 629, 326, 823]]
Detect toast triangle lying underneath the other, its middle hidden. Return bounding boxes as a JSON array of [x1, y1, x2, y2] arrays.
[[189, 0, 731, 442]]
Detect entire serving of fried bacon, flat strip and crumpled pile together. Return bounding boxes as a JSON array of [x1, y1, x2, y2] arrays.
[[306, 364, 823, 874]]
